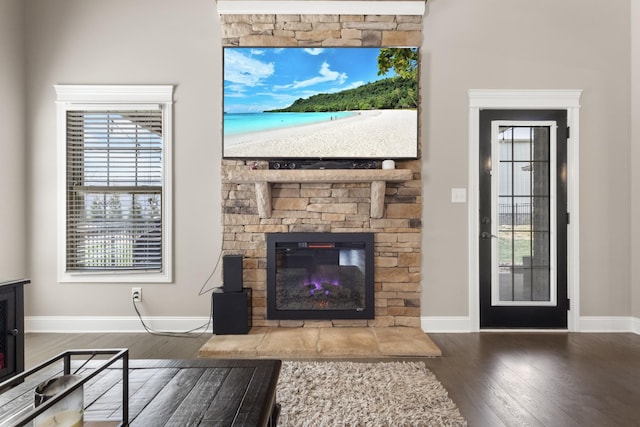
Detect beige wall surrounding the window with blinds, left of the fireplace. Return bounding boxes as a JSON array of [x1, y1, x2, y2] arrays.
[[26, 0, 222, 326]]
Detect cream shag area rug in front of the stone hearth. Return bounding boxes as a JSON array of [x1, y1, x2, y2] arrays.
[[276, 361, 467, 427]]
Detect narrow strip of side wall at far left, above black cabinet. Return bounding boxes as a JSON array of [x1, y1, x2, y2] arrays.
[[0, 0, 27, 280]]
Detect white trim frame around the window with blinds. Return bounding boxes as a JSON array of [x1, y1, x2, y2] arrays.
[[54, 85, 173, 283]]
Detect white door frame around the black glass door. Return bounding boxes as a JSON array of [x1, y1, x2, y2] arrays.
[[468, 89, 582, 332]]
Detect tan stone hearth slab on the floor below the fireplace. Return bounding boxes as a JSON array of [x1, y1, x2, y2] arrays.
[[198, 326, 442, 359]]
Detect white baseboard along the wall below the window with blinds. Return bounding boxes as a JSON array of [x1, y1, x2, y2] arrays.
[[24, 316, 213, 333]]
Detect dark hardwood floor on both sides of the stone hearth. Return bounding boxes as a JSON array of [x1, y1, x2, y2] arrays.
[[25, 333, 640, 427]]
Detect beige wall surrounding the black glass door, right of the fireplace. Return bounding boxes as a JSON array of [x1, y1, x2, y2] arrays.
[[422, 0, 631, 316]]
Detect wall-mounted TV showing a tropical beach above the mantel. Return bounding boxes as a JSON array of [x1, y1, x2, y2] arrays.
[[222, 47, 418, 159]]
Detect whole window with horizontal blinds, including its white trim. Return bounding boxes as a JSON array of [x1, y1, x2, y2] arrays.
[[56, 85, 172, 282]]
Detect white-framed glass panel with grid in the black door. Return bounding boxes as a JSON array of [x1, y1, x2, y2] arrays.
[[491, 122, 557, 306]]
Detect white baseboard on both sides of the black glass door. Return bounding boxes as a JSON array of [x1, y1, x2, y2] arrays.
[[420, 316, 640, 335]]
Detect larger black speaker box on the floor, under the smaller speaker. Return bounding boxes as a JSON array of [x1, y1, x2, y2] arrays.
[[212, 288, 251, 335]]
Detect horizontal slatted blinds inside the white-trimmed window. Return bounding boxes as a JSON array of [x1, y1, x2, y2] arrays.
[[66, 107, 163, 272]]
